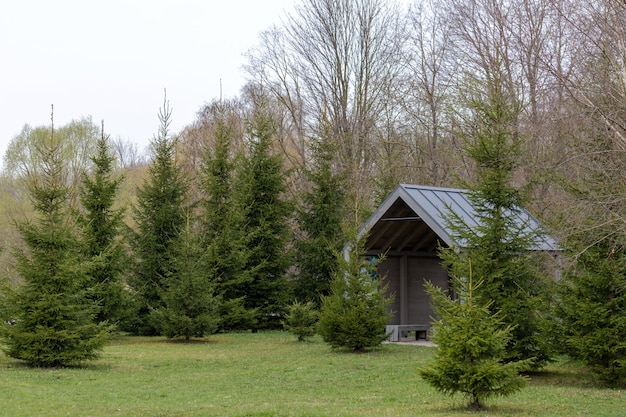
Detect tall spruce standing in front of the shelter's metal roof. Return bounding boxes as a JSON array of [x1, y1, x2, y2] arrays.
[[440, 79, 549, 367]]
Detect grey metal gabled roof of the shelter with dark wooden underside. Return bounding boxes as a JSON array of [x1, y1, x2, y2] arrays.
[[361, 184, 560, 253]]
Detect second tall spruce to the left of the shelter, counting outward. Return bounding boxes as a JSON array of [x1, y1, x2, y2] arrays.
[[235, 104, 291, 329]]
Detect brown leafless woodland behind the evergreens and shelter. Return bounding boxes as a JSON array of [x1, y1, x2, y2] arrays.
[[0, 0, 626, 380]]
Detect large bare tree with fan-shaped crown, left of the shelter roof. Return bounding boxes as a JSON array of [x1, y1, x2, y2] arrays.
[[248, 0, 402, 221]]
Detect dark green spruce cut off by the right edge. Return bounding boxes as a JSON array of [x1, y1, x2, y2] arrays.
[[554, 118, 626, 386]]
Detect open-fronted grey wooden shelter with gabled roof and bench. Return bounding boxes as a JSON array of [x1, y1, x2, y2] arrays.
[[360, 184, 558, 341]]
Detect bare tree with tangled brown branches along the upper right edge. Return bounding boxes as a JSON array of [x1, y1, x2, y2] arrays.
[[555, 0, 626, 240]]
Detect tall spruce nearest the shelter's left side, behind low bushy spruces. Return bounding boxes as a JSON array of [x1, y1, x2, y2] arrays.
[[294, 134, 347, 308]]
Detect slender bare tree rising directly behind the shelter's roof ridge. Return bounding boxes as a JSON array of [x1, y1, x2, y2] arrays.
[[399, 0, 458, 185]]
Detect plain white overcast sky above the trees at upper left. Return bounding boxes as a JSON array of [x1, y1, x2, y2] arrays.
[[0, 0, 296, 166]]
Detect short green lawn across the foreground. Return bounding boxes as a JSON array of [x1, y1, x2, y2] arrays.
[[0, 332, 626, 417]]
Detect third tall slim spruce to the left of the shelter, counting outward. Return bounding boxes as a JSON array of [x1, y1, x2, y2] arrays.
[[200, 105, 256, 330]]
